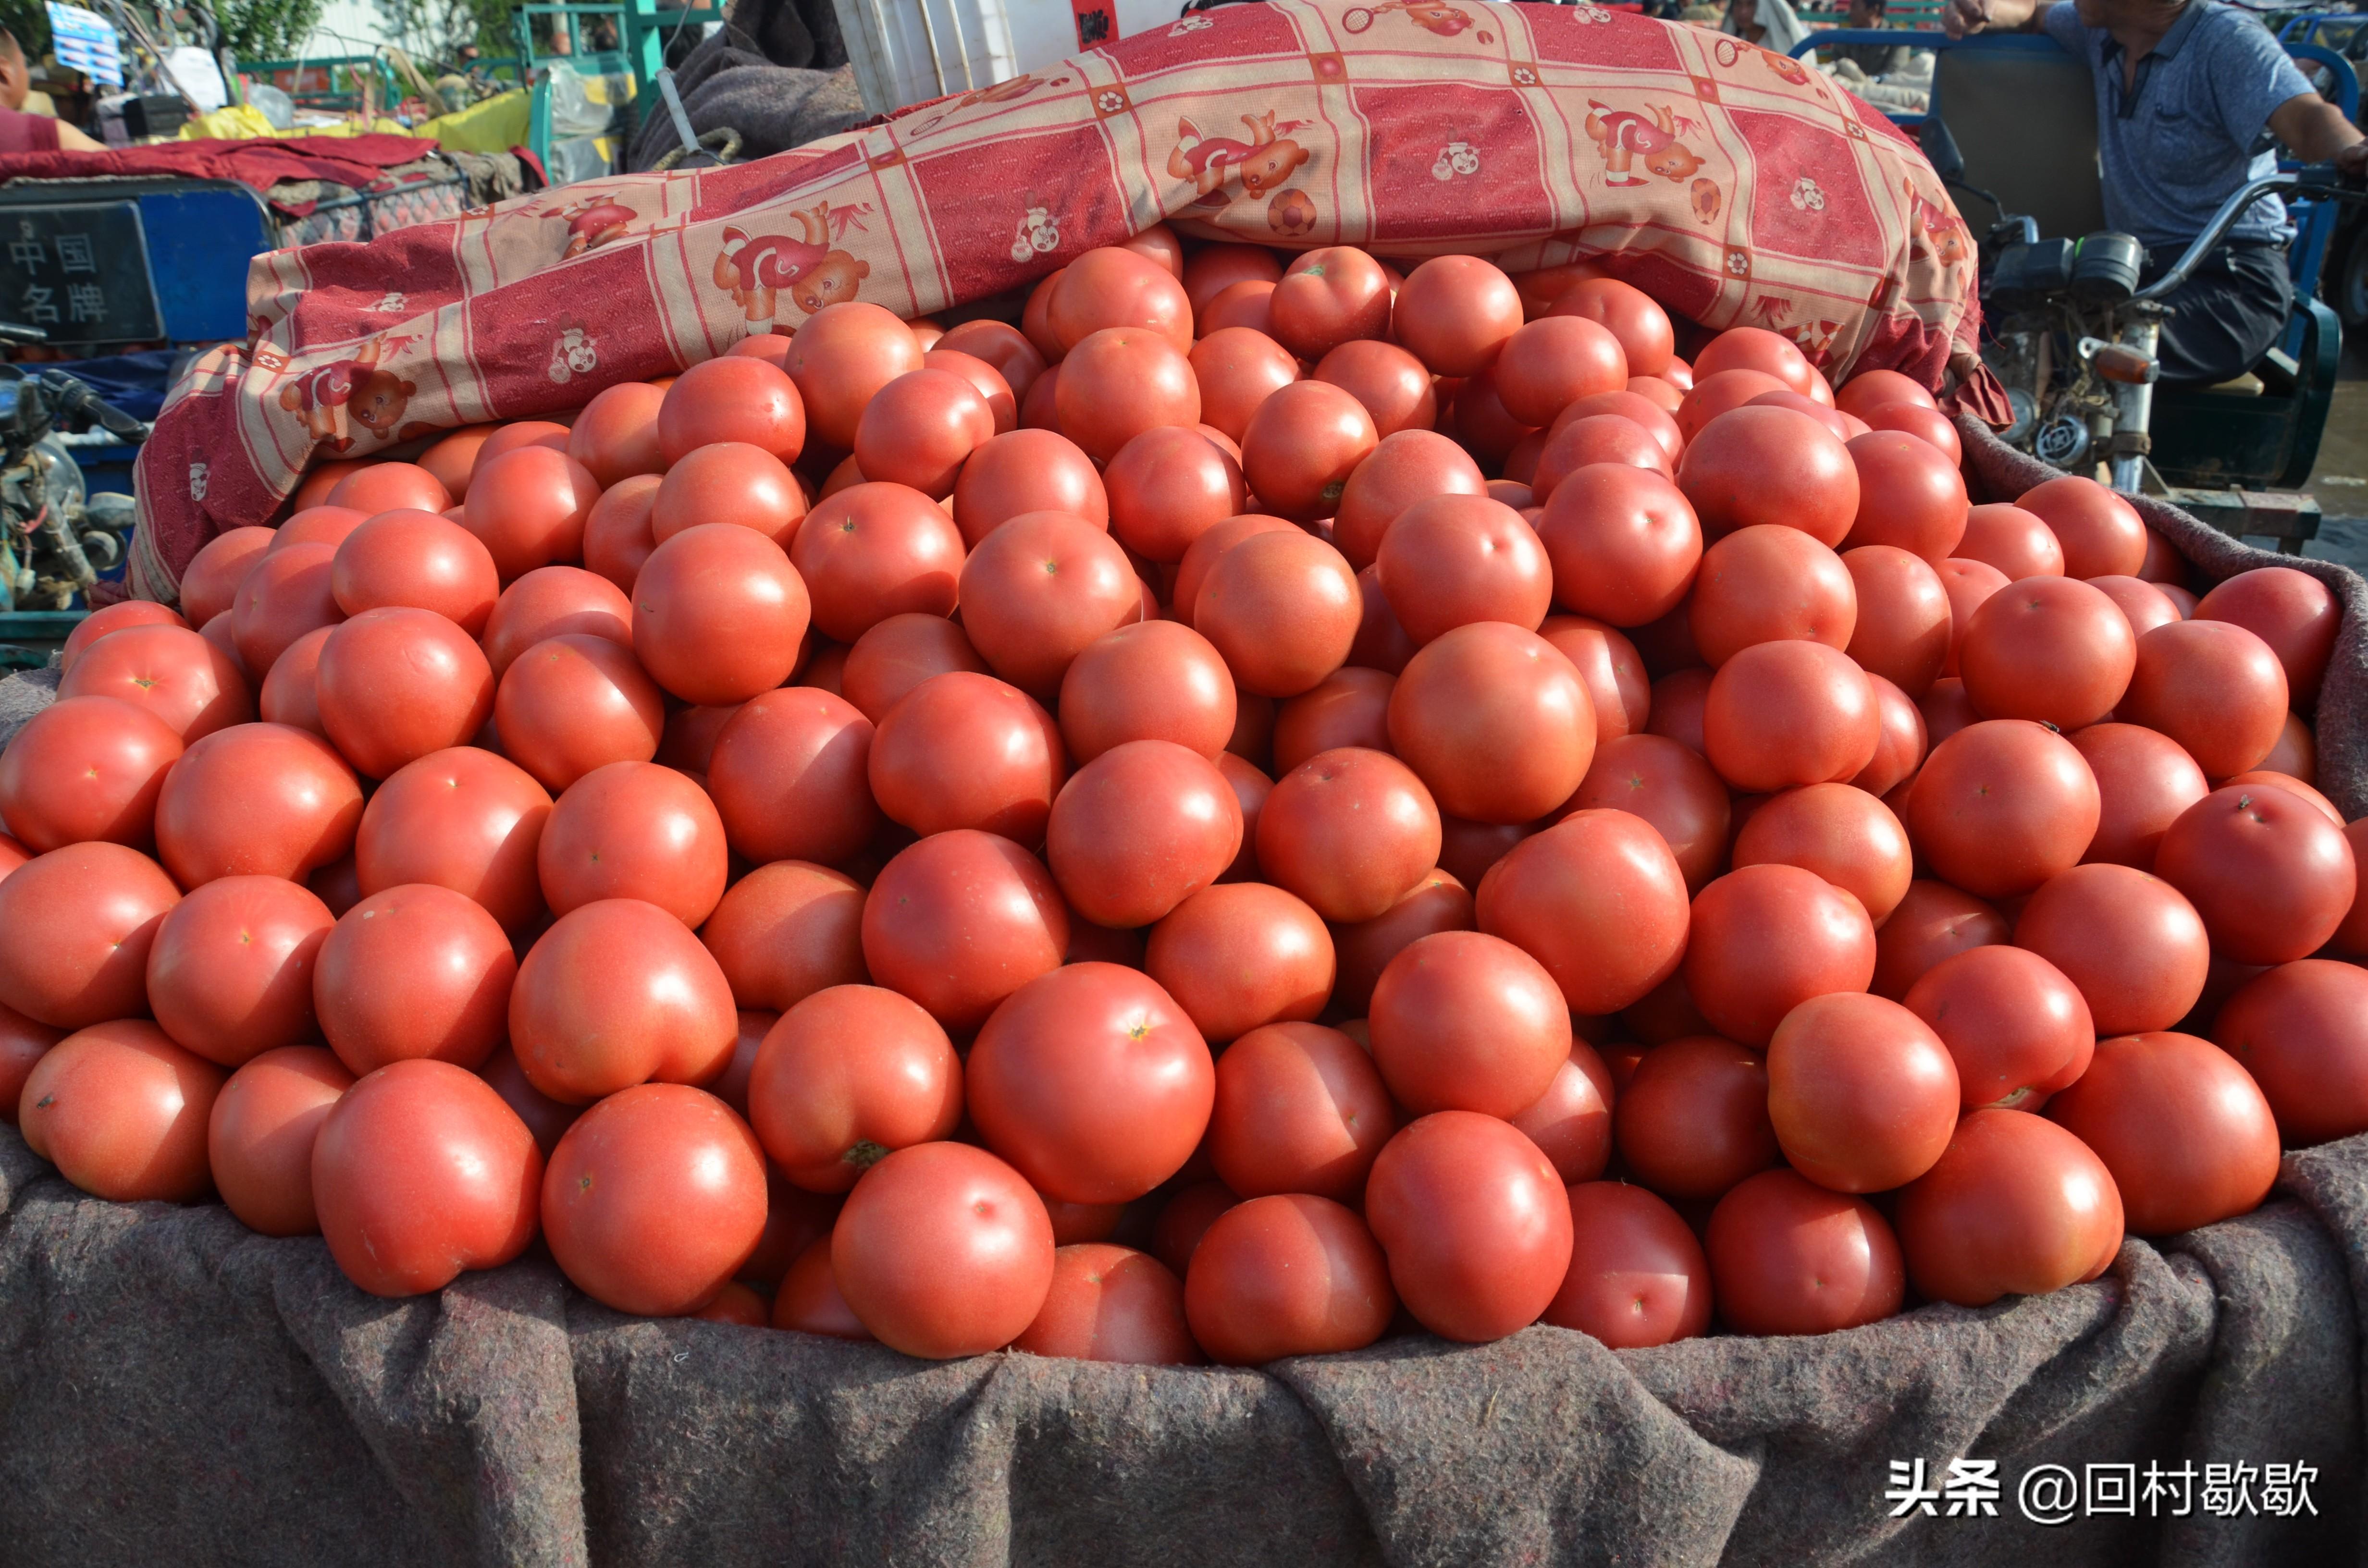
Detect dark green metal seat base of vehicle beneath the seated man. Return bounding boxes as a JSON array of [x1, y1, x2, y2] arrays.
[[2148, 296, 2344, 490]]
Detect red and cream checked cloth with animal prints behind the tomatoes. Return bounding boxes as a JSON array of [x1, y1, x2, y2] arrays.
[[130, 0, 1987, 599]]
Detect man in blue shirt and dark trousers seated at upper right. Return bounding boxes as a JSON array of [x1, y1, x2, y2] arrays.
[[1942, 0, 2368, 384]]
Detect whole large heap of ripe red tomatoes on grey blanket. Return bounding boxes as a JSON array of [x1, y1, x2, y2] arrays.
[[0, 230, 2368, 1364]]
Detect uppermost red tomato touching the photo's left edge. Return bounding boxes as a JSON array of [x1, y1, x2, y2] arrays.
[[0, 696, 182, 853]]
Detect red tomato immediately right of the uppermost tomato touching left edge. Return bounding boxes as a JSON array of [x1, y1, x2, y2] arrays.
[[157, 725, 362, 888]]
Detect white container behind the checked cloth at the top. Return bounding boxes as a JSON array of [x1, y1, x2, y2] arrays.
[[831, 0, 1184, 114]]
